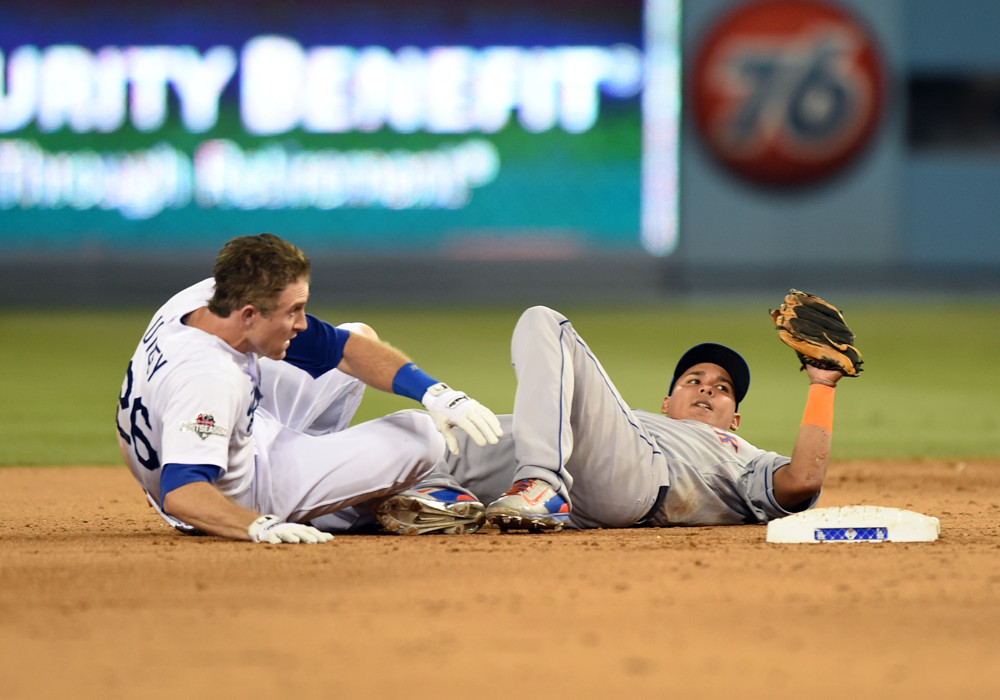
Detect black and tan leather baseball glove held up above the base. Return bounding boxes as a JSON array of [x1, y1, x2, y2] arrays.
[[771, 289, 862, 377]]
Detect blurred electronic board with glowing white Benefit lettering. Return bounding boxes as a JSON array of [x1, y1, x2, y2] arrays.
[[0, 0, 680, 258]]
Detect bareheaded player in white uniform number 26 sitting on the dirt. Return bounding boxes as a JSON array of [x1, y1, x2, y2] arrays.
[[117, 234, 501, 543]]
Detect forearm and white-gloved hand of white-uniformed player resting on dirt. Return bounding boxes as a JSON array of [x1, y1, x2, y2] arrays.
[[163, 481, 333, 544]]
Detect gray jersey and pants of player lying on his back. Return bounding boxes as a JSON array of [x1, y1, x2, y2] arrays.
[[424, 307, 815, 528]]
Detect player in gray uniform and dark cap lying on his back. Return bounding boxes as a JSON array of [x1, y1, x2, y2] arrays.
[[386, 306, 843, 531]]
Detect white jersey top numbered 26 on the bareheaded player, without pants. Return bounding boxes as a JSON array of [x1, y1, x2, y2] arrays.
[[117, 279, 260, 507]]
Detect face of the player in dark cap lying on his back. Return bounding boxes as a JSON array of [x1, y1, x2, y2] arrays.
[[663, 362, 740, 430]]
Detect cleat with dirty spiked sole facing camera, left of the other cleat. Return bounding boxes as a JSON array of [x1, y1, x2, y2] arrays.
[[373, 487, 486, 535]]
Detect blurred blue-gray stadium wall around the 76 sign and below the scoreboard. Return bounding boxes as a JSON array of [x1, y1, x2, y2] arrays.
[[0, 0, 1000, 308]]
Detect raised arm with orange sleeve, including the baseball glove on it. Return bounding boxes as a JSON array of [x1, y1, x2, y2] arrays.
[[771, 289, 862, 511]]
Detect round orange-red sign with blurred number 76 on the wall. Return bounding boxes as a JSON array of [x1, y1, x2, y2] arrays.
[[688, 0, 884, 186]]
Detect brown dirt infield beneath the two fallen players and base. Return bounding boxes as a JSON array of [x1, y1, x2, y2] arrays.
[[0, 461, 1000, 700]]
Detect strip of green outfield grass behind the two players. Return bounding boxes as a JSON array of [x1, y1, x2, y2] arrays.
[[0, 303, 1000, 466]]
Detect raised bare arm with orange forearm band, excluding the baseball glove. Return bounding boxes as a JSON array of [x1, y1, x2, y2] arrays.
[[774, 365, 844, 512]]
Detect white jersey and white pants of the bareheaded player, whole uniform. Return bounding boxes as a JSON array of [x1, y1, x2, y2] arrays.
[[117, 279, 444, 531]]
